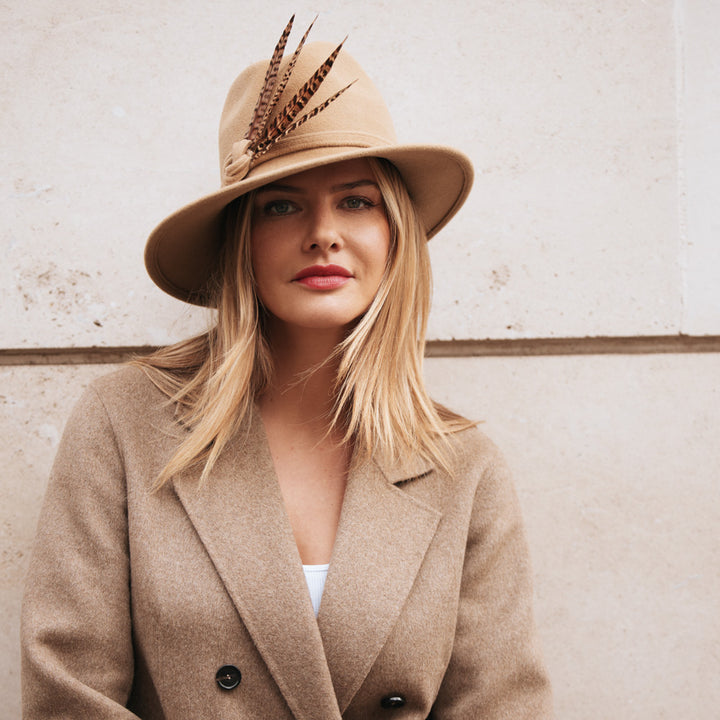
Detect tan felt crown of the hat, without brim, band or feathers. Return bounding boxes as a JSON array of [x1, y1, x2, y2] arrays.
[[219, 42, 397, 184]]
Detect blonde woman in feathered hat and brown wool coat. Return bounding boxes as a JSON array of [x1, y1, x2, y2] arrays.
[[23, 16, 550, 720]]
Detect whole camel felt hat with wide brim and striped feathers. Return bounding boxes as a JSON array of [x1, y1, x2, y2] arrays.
[[145, 20, 473, 305]]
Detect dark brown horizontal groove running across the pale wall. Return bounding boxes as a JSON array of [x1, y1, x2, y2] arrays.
[[0, 335, 720, 365]]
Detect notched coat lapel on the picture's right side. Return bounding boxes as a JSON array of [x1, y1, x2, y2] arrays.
[[318, 452, 441, 712]]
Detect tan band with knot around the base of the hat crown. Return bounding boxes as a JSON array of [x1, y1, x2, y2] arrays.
[[222, 131, 395, 185]]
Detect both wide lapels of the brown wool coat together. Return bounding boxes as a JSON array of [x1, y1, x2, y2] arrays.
[[173, 410, 440, 720]]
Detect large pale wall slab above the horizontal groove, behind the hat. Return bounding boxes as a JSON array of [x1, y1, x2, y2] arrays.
[[0, 0, 688, 348]]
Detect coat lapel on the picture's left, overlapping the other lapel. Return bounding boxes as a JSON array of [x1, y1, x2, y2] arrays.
[[174, 410, 340, 720]]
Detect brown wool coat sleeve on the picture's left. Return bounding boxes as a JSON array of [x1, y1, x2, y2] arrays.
[[21, 389, 141, 720]]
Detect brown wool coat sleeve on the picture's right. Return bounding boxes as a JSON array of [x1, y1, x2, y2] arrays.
[[430, 451, 552, 720]]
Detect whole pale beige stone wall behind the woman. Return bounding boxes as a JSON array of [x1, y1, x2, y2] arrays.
[[0, 0, 720, 720]]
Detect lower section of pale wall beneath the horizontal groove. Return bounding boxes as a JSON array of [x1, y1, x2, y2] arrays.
[[0, 355, 720, 720]]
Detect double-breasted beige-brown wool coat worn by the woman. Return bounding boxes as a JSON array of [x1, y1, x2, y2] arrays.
[[22, 367, 551, 720]]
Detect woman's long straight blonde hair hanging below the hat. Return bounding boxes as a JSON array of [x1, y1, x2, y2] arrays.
[[134, 158, 473, 487]]
